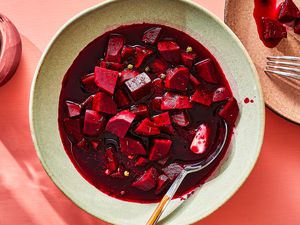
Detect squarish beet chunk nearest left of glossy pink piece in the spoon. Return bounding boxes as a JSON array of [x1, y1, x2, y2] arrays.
[[149, 139, 172, 161]]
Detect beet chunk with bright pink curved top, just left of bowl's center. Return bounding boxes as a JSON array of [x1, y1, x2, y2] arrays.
[[105, 110, 135, 138]]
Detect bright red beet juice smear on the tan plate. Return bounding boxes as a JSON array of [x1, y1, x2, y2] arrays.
[[253, 0, 281, 48]]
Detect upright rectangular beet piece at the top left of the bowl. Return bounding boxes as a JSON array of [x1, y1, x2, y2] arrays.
[[105, 35, 124, 63]]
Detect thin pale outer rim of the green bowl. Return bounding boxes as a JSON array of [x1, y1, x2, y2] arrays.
[[29, 0, 265, 224]]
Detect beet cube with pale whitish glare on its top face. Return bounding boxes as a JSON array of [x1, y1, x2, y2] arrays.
[[125, 73, 152, 101]]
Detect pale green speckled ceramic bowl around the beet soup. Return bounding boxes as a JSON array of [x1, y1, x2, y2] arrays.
[[30, 0, 264, 225]]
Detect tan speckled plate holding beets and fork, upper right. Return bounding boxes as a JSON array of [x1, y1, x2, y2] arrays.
[[225, 0, 300, 124]]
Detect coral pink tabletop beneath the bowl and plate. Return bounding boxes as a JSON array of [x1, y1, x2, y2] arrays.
[[0, 0, 300, 225]]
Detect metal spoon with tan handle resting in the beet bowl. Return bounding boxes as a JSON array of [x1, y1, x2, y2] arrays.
[[146, 120, 228, 225]]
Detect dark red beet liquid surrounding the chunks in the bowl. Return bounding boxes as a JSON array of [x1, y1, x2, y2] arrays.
[[58, 24, 236, 203]]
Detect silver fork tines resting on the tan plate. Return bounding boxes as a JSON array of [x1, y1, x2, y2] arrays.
[[265, 56, 300, 80]]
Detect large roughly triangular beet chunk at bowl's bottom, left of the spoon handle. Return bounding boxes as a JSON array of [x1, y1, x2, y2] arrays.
[[132, 167, 158, 191]]
